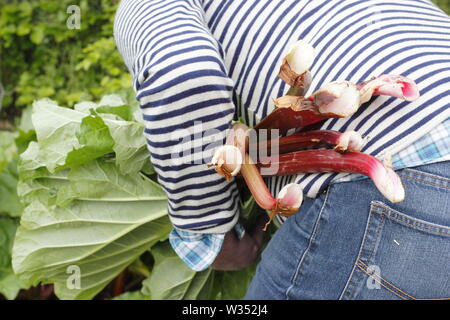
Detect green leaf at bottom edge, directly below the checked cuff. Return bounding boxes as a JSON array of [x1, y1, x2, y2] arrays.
[[142, 241, 213, 300]]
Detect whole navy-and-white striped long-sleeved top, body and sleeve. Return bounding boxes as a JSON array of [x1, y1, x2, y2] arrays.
[[115, 0, 450, 268]]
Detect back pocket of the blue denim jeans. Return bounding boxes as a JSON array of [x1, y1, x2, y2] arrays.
[[340, 201, 450, 300]]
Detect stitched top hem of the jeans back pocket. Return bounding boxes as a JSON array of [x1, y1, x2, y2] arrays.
[[373, 202, 450, 237]]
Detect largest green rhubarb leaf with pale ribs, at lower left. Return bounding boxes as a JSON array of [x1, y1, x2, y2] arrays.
[[13, 149, 171, 299]]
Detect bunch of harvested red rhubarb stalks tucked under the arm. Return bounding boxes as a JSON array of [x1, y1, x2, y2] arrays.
[[210, 41, 419, 228]]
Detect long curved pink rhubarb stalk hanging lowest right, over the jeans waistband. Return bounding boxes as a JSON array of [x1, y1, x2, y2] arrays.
[[258, 150, 405, 202]]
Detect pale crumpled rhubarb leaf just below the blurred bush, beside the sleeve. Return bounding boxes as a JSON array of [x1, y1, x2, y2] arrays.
[[32, 96, 150, 174]]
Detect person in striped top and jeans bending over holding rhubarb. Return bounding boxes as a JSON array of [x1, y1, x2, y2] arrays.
[[114, 0, 450, 299]]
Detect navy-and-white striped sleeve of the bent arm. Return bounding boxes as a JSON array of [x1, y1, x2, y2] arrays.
[[114, 0, 239, 234]]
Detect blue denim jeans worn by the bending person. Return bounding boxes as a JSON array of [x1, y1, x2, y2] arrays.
[[246, 162, 450, 300]]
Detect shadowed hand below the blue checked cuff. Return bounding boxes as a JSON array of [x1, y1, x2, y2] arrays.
[[211, 214, 268, 271]]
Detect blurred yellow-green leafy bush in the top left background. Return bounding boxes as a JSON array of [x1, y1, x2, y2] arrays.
[[0, 0, 131, 115]]
